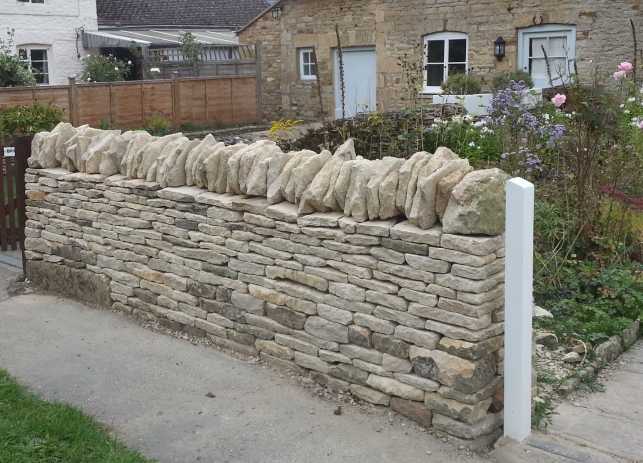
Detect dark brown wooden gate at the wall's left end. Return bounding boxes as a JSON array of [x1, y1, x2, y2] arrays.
[[0, 136, 33, 269]]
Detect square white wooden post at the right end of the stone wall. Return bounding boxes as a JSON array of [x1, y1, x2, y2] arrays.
[[504, 178, 534, 442]]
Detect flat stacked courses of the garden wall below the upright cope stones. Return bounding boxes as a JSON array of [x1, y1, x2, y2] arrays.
[[26, 168, 504, 446]]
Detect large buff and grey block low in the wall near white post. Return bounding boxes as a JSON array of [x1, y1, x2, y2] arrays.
[[409, 346, 496, 394]]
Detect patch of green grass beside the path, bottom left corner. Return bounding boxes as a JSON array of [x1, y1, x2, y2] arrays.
[[0, 370, 152, 463]]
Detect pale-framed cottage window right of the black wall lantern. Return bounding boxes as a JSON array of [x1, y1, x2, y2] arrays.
[[518, 24, 576, 88]]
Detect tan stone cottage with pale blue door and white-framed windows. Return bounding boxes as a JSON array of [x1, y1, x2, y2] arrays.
[[238, 0, 643, 120]]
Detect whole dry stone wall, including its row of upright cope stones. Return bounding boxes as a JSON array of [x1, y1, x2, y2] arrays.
[[26, 124, 506, 445]]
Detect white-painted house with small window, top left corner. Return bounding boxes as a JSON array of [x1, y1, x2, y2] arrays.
[[0, 0, 98, 85]]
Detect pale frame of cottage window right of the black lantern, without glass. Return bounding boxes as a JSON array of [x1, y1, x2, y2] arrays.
[[518, 24, 576, 88]]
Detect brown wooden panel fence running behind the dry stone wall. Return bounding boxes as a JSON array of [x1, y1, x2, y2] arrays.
[[0, 76, 261, 130]]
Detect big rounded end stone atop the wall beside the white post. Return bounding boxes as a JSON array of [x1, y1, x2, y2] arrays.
[[442, 169, 511, 236]]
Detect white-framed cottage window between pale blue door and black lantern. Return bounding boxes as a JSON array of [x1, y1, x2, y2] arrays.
[[424, 32, 469, 93]]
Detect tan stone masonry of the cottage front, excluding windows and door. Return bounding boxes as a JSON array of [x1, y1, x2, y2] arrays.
[[240, 0, 643, 120]]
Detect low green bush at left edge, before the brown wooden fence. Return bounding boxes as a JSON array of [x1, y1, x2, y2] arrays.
[[0, 103, 63, 134]]
